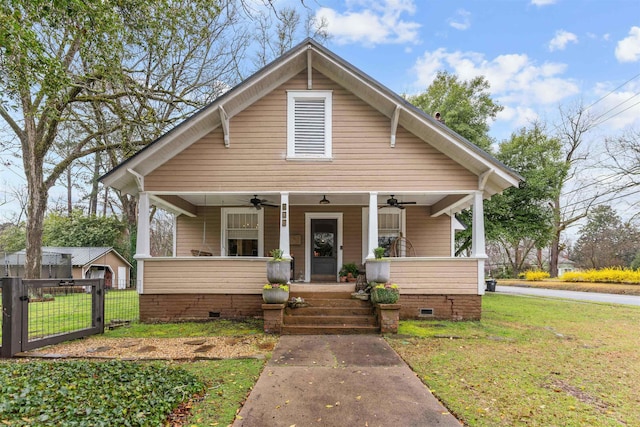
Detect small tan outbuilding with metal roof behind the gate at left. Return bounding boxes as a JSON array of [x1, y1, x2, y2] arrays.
[[5, 246, 131, 289]]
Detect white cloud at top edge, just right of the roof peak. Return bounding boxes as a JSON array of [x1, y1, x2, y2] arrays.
[[316, 0, 420, 46]]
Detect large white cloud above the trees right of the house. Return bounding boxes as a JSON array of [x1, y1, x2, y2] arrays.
[[413, 48, 579, 126]]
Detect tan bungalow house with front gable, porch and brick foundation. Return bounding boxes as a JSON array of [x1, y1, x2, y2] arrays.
[[101, 39, 521, 321]]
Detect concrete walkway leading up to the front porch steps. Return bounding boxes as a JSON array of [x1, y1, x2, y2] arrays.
[[233, 335, 461, 427]]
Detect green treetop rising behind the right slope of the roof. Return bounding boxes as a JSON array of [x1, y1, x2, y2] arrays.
[[407, 71, 504, 151]]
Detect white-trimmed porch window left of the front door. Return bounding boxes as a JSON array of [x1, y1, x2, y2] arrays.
[[220, 208, 264, 256]]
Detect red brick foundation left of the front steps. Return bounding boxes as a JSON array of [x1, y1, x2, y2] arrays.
[[140, 294, 263, 322]]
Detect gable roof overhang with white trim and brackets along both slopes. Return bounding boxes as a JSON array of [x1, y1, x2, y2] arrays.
[[100, 39, 523, 195]]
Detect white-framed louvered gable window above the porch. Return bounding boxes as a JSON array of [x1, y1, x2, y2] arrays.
[[287, 90, 332, 159]]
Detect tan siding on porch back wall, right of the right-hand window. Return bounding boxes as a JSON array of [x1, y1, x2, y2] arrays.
[[406, 207, 451, 257]]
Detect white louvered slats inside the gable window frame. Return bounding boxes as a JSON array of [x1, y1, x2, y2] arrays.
[[294, 98, 326, 156]]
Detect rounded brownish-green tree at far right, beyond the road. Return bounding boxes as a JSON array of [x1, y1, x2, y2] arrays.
[[573, 205, 640, 268]]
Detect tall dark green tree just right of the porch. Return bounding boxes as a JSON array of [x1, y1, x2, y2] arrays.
[[485, 124, 564, 274]]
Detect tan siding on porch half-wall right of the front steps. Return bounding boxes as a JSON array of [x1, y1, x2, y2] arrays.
[[391, 258, 478, 295]]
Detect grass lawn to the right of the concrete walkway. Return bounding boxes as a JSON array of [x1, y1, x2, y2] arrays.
[[388, 294, 640, 427]]
